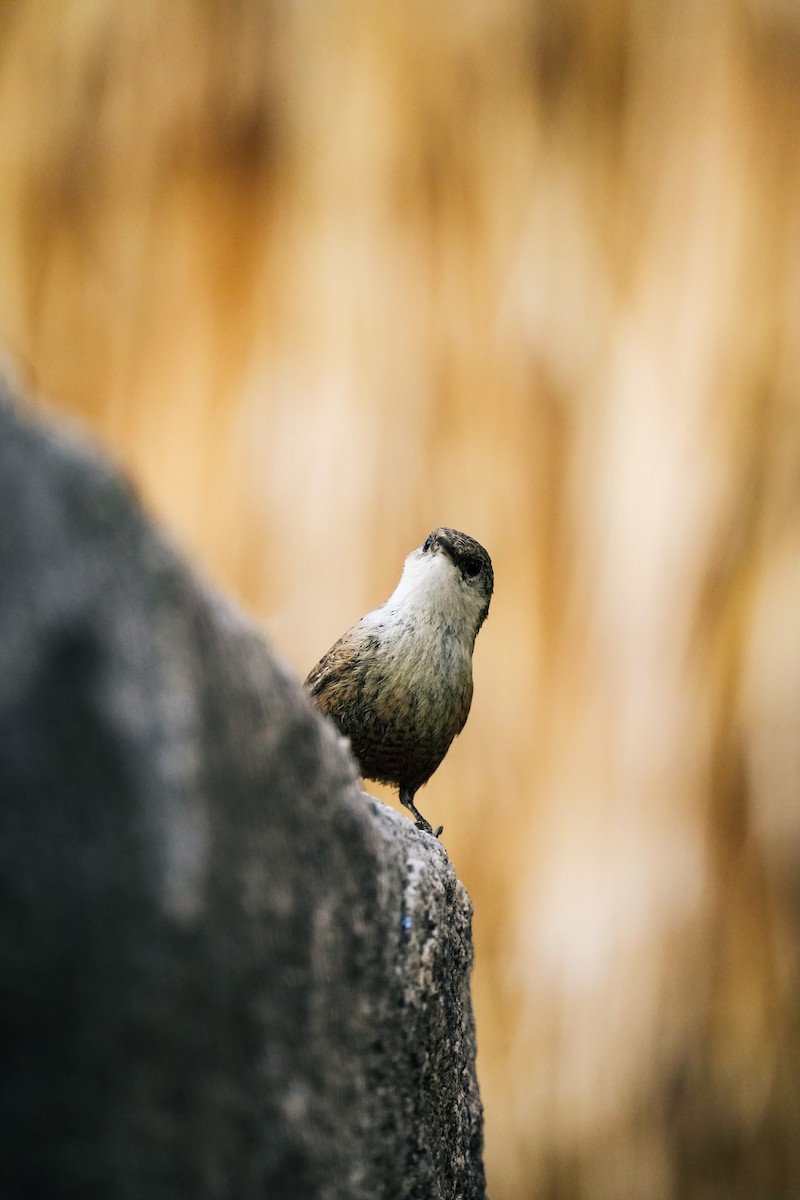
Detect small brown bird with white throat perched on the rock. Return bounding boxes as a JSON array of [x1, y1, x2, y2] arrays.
[[305, 526, 494, 838]]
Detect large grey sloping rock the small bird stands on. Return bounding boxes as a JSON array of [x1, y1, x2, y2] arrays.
[[0, 391, 485, 1200]]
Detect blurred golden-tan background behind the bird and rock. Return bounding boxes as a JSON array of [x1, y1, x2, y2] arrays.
[[0, 0, 800, 1200]]
